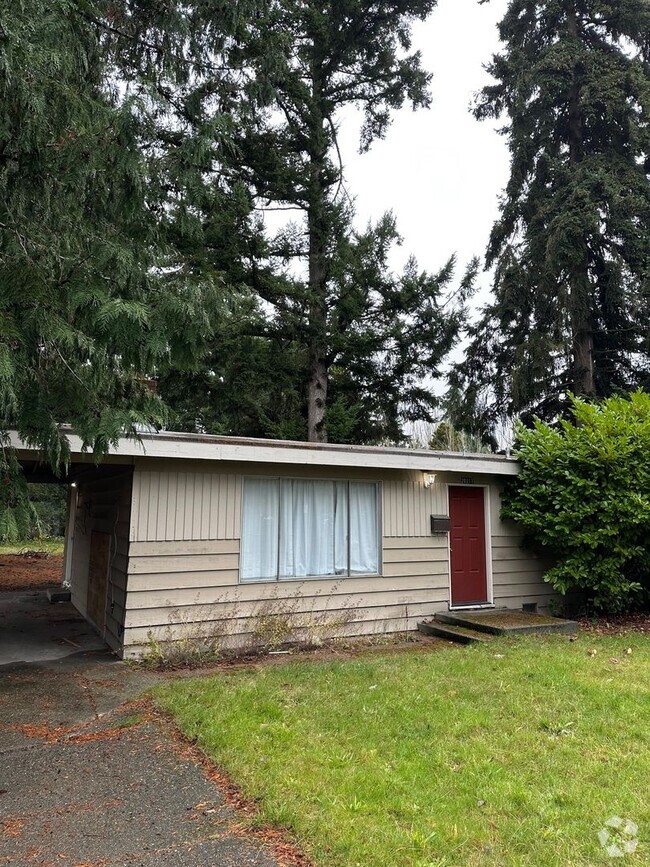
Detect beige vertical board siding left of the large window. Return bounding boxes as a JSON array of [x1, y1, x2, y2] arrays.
[[130, 470, 241, 542]]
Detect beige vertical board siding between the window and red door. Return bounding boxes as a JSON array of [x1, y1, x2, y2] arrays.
[[382, 479, 449, 539]]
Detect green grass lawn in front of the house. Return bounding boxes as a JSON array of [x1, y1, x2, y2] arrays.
[[155, 636, 650, 867]]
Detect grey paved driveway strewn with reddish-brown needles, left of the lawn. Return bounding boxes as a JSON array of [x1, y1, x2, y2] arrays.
[[0, 596, 279, 867]]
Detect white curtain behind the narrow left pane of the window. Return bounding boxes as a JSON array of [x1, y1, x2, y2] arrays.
[[239, 479, 280, 581]]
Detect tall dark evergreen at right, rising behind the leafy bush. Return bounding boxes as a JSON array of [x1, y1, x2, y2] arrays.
[[453, 0, 650, 432]]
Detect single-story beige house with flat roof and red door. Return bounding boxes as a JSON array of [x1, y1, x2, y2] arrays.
[[13, 432, 554, 658]]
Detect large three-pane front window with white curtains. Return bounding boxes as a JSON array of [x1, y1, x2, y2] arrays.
[[240, 479, 379, 581]]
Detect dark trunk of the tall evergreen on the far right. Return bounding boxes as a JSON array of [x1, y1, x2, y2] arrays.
[[567, 7, 596, 396]]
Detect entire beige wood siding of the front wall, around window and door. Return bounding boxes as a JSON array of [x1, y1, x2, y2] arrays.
[[119, 461, 553, 656]]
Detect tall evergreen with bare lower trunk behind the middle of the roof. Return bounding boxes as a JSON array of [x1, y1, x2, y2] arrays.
[[233, 0, 471, 442]]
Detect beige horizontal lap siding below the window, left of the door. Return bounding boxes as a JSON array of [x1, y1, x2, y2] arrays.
[[124, 536, 448, 656]]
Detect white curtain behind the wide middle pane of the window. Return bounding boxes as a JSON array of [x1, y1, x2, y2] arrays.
[[279, 479, 348, 578]]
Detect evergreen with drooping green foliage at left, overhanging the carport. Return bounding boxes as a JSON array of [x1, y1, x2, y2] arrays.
[[0, 0, 219, 535]]
